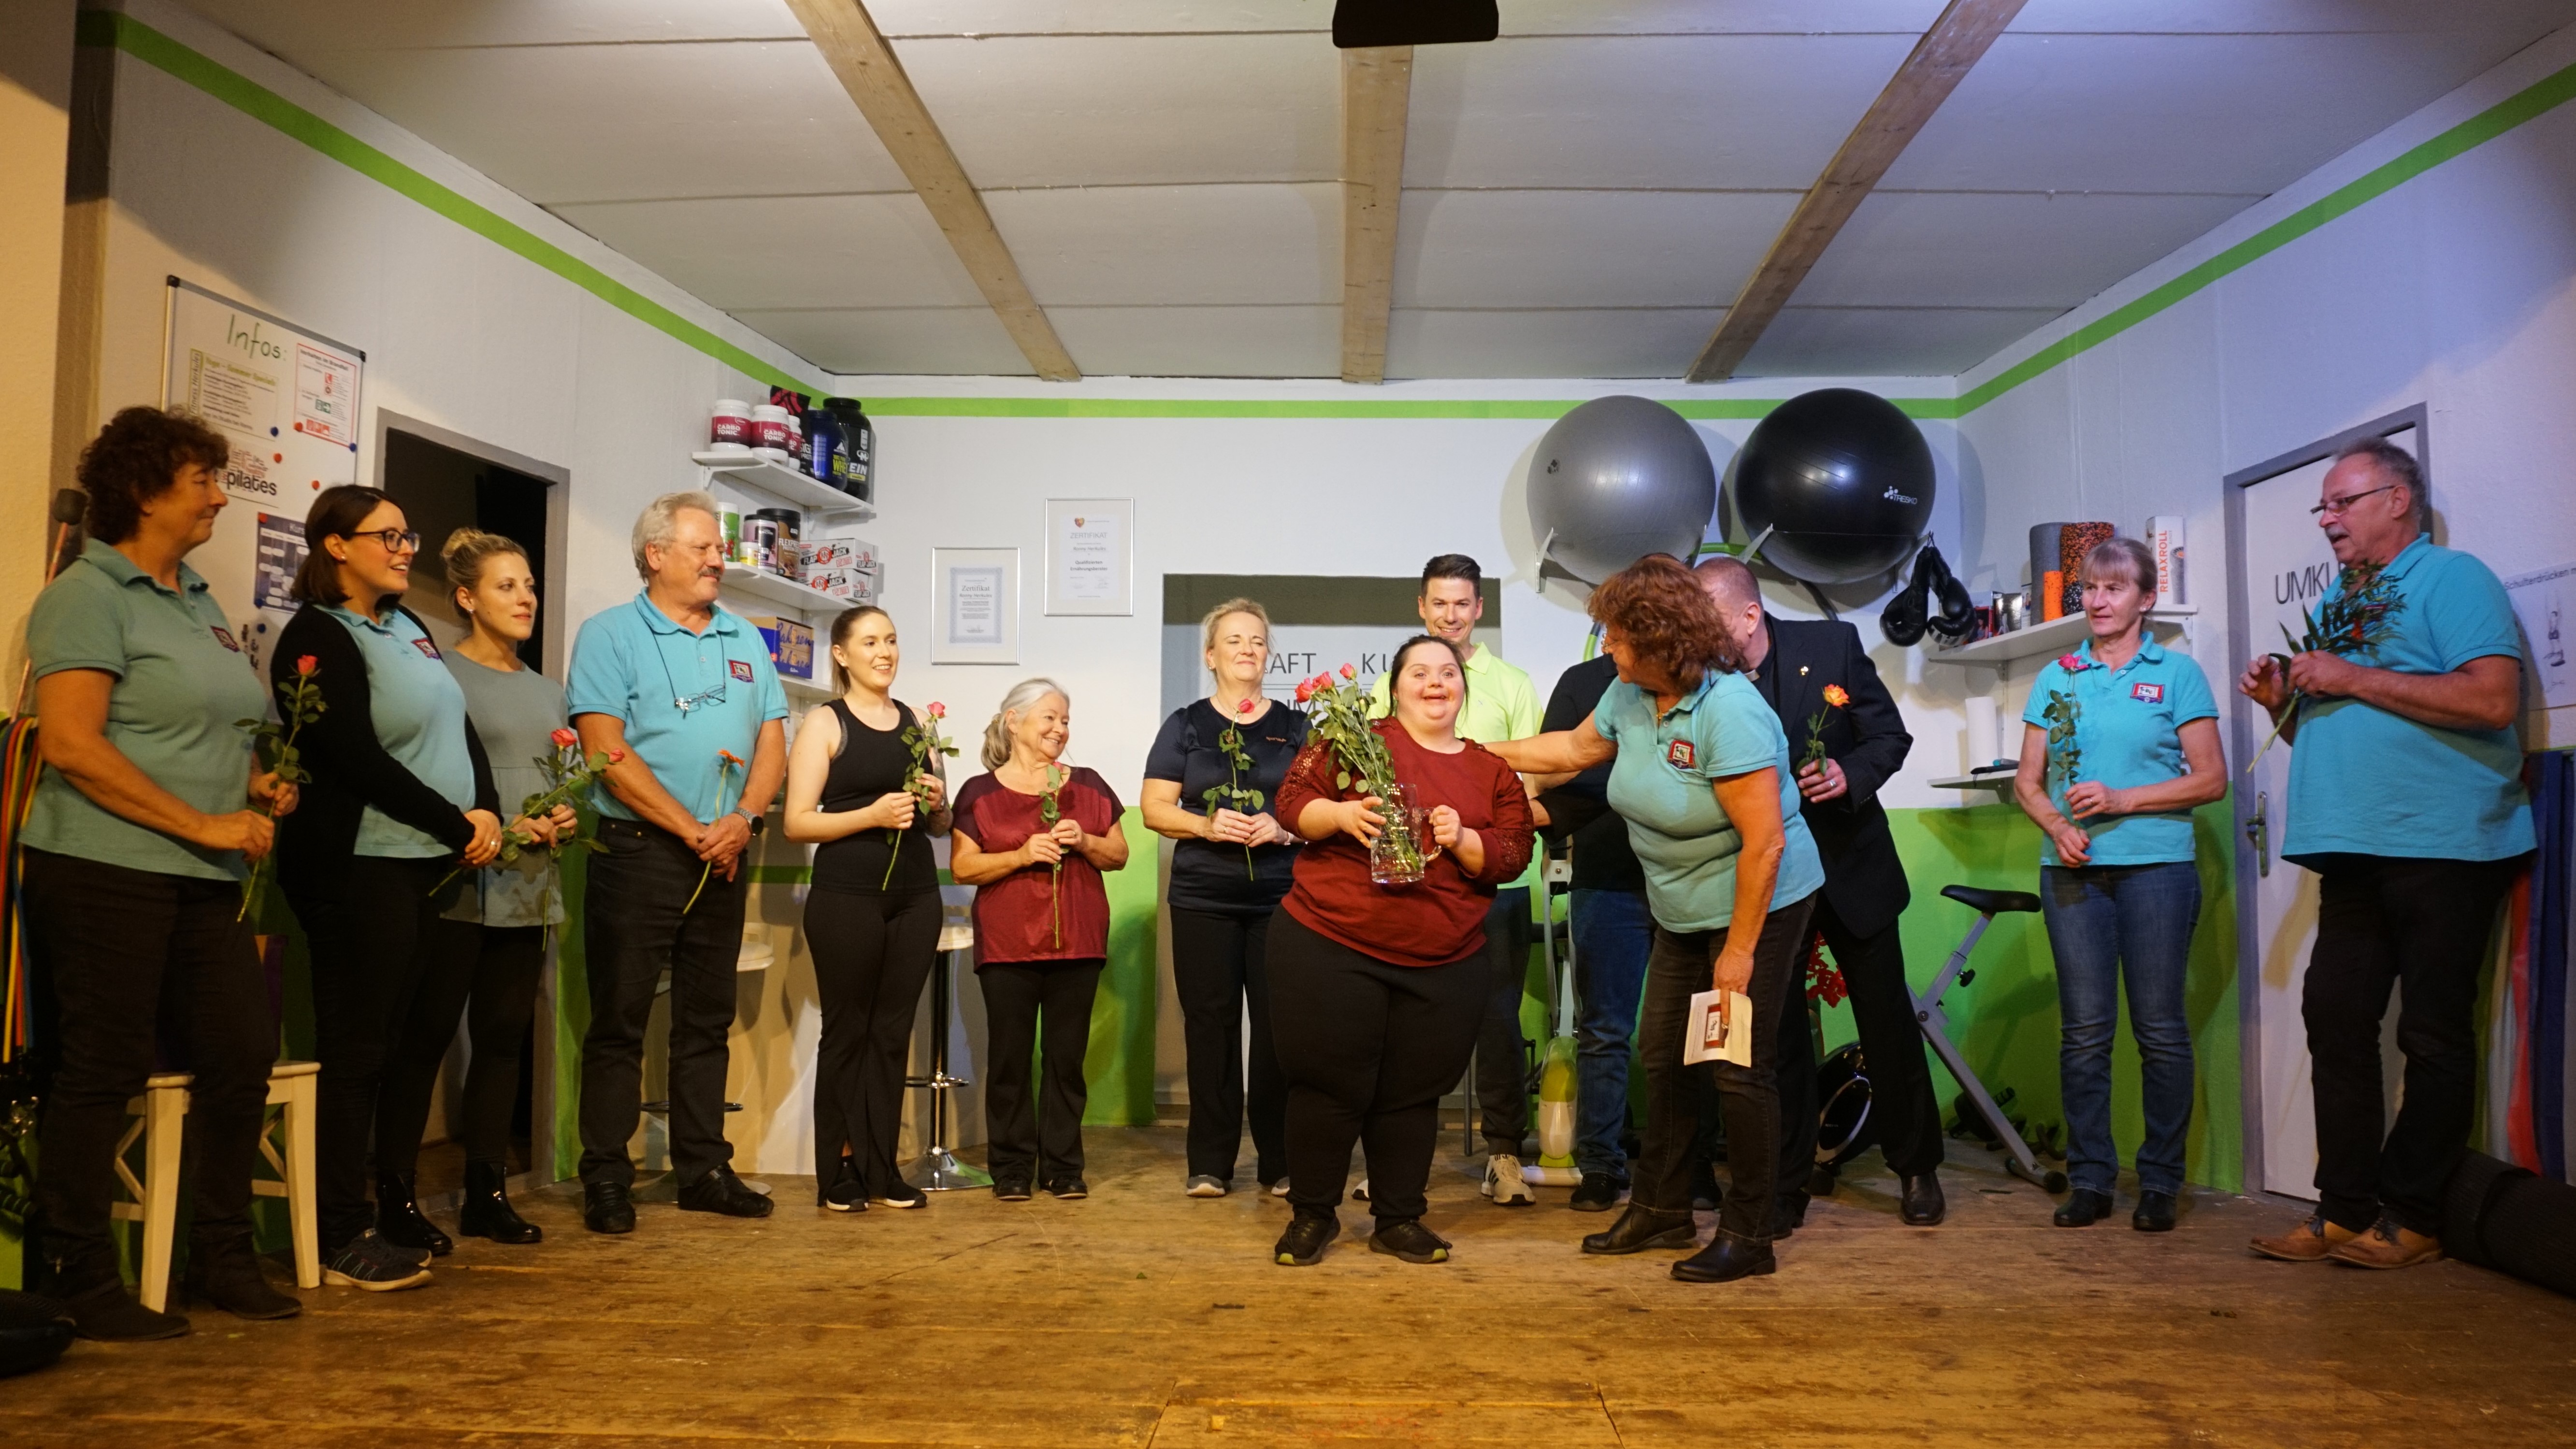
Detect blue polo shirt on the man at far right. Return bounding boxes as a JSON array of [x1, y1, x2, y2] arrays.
[[2280, 535, 2532, 865]]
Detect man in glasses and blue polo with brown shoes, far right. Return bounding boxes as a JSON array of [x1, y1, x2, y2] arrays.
[[2236, 438, 2532, 1269]]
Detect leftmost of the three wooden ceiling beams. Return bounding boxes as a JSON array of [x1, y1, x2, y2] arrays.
[[788, 0, 1082, 384]]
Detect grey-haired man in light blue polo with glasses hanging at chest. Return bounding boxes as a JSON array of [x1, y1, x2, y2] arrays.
[[564, 494, 788, 1233]]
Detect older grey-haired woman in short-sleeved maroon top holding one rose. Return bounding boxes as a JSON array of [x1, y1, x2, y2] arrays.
[[948, 679, 1126, 1202]]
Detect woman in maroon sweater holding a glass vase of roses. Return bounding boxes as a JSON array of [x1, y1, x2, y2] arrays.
[[1270, 633, 1530, 1269]]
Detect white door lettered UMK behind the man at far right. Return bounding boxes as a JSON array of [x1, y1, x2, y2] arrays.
[[2210, 419, 2421, 1202]]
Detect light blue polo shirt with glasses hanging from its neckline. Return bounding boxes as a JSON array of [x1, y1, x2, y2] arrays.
[[564, 594, 788, 821]]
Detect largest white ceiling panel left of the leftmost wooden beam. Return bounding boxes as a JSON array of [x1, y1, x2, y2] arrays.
[[295, 41, 909, 206]]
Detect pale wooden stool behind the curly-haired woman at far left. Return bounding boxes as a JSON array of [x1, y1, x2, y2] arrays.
[[108, 1061, 322, 1313]]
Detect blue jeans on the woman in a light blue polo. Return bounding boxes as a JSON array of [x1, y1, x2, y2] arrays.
[[2040, 862, 2200, 1191]]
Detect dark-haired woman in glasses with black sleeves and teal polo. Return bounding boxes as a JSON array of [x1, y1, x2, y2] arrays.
[[268, 487, 500, 1292]]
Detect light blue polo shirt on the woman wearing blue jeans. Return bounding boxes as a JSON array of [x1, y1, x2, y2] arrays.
[[2022, 638, 2218, 865]]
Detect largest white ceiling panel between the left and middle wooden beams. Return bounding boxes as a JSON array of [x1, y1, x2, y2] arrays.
[[896, 36, 1342, 188]]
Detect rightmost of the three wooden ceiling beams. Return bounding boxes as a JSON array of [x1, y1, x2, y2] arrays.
[[1687, 0, 2022, 384]]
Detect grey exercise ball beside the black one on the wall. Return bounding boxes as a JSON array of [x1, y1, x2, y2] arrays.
[[1530, 396, 1718, 584]]
